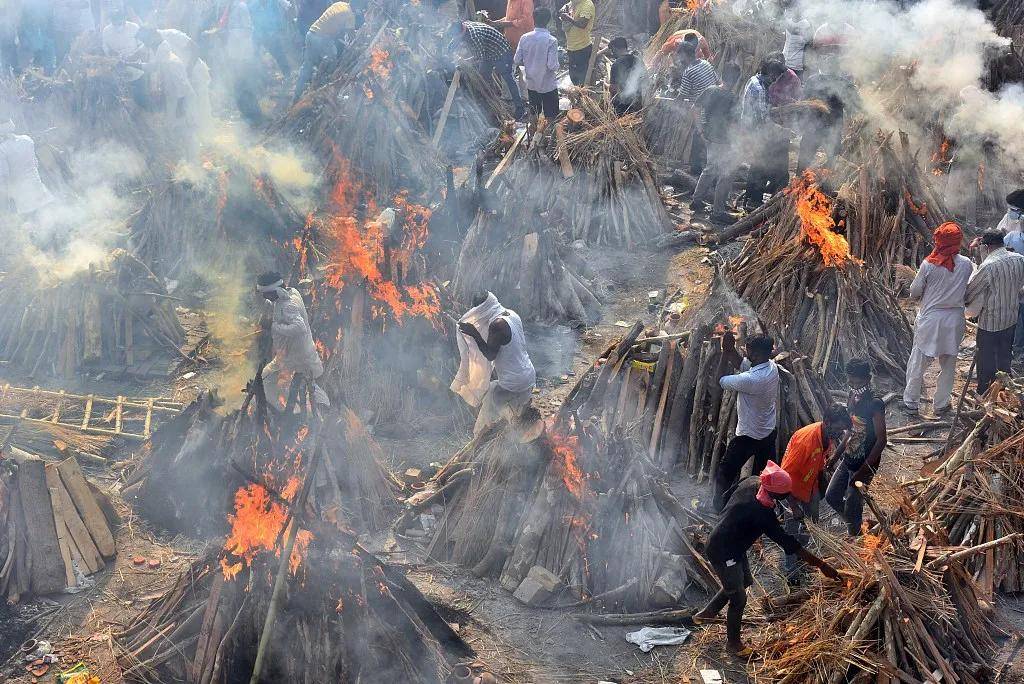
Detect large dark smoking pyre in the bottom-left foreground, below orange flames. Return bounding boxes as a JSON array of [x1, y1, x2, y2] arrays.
[[115, 516, 473, 684]]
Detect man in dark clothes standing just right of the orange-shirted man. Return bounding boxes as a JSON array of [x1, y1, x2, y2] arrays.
[[825, 358, 887, 537]]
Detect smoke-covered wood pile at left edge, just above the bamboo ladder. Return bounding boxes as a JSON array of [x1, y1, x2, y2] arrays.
[[0, 250, 188, 378]]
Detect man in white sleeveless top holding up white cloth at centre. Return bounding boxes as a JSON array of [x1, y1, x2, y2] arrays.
[[452, 292, 537, 435]]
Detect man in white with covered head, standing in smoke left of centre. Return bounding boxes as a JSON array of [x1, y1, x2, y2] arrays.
[[256, 271, 331, 407]]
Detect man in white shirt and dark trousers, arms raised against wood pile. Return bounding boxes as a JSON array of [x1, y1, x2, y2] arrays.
[[714, 335, 778, 511]]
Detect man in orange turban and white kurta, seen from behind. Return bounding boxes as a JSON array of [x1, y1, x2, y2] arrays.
[[903, 221, 974, 416]]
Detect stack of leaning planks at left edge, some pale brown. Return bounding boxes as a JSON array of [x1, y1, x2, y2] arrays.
[[0, 447, 116, 603]]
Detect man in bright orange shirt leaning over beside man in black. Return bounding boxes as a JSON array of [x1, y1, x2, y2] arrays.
[[781, 404, 853, 585]]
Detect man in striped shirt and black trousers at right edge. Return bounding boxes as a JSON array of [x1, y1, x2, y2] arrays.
[[965, 230, 1024, 394]]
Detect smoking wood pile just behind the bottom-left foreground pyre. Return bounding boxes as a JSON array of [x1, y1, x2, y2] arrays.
[[123, 378, 398, 537]]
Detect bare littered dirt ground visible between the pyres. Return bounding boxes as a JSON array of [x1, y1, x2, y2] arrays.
[[0, 236, 1024, 684]]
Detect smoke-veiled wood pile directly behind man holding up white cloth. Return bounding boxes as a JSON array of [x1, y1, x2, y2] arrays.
[[452, 151, 601, 324]]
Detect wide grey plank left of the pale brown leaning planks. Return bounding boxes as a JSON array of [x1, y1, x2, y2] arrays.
[[10, 447, 68, 595]]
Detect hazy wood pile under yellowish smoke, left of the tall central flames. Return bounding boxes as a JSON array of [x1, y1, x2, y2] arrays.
[[128, 154, 305, 282]]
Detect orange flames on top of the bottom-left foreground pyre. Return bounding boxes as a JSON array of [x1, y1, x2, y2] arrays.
[[220, 477, 312, 580]]
